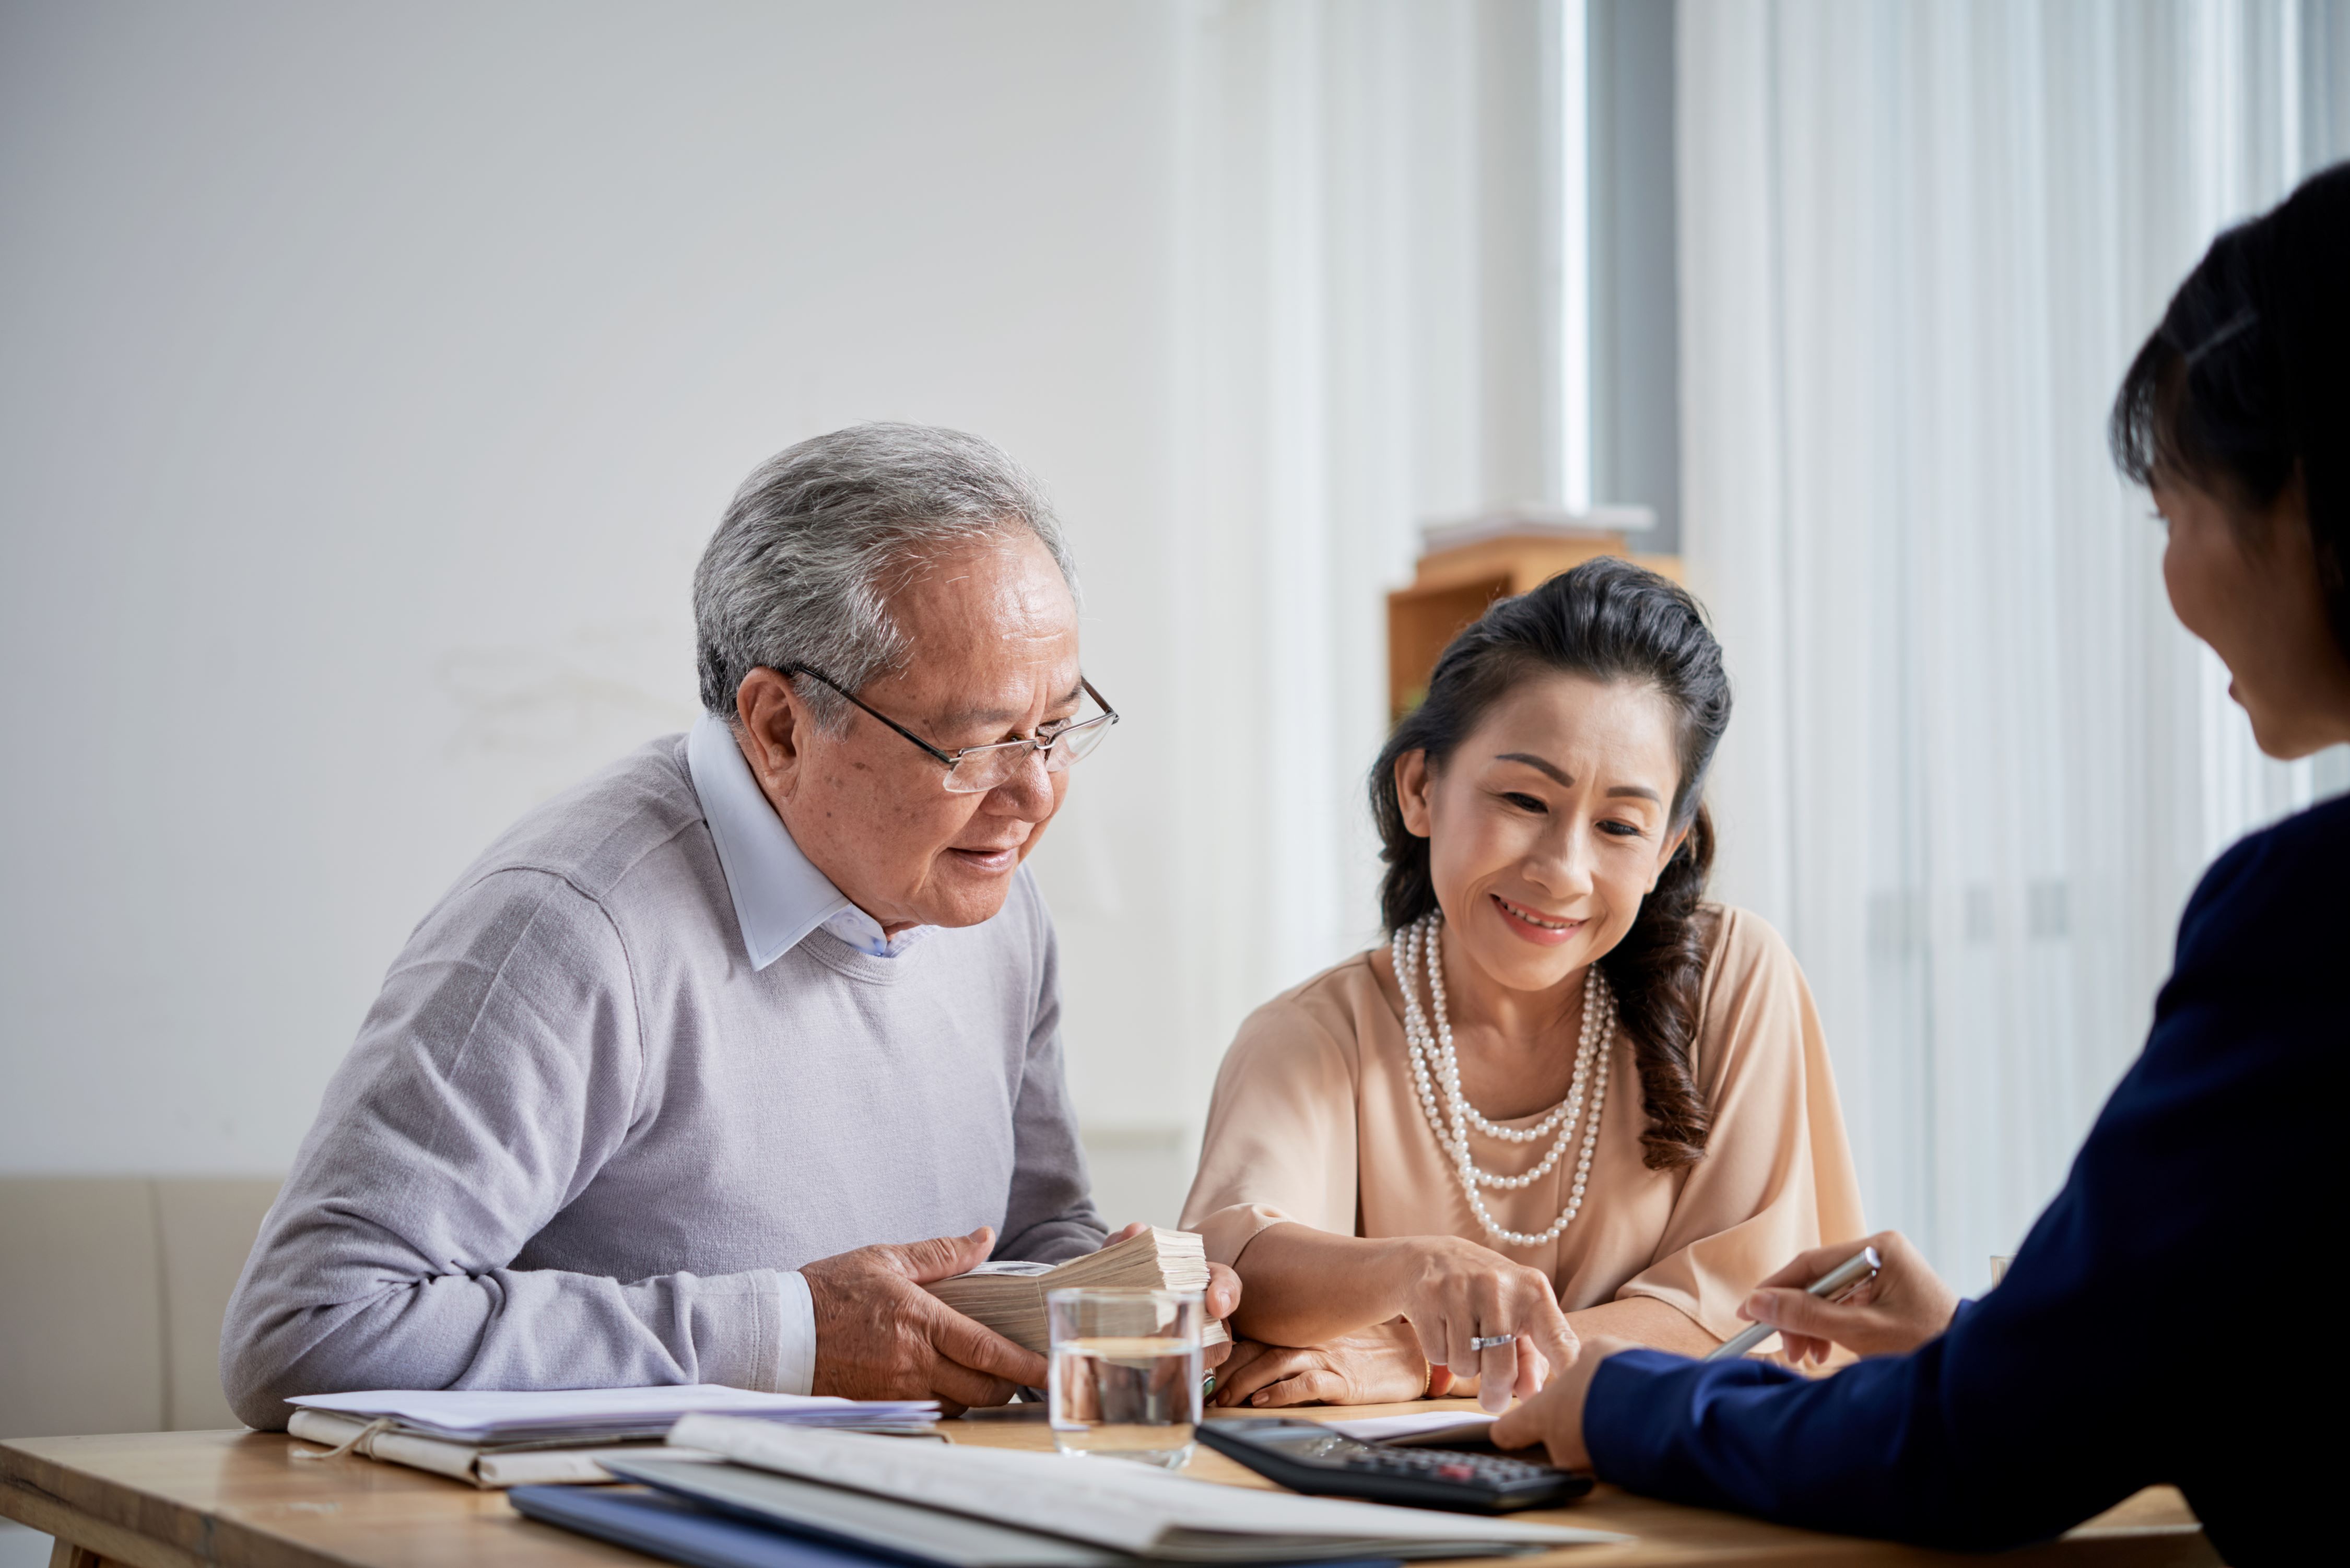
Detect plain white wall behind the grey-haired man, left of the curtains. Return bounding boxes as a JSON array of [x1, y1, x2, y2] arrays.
[[0, 0, 1222, 1201]]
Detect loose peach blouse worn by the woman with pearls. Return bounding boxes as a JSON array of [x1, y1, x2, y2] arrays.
[[1182, 905, 1866, 1338]]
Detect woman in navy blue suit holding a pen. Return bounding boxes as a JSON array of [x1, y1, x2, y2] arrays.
[[1495, 164, 2350, 1568]]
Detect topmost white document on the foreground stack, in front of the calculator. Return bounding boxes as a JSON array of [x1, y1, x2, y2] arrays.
[[670, 1415, 1631, 1563]]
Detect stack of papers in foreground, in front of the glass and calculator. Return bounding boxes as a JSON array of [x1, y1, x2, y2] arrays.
[[575, 1415, 1626, 1568]]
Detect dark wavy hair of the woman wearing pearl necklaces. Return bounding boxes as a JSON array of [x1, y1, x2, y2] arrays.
[[1370, 555, 1730, 1171]]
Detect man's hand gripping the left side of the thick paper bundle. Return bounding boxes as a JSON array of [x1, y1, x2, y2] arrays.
[[799, 1225, 1046, 1413]]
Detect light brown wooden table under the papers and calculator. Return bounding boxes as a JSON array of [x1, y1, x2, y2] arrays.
[[0, 1401, 2218, 1568]]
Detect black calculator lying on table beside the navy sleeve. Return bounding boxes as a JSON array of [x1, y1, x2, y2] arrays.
[[1194, 1415, 1591, 1514]]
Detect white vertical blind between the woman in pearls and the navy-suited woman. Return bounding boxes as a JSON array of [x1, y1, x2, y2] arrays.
[[1678, 0, 2350, 1288]]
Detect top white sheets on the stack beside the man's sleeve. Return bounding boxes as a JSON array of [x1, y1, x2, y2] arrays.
[[287, 1382, 938, 1443]]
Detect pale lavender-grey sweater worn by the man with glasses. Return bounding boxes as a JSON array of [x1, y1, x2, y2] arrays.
[[221, 736, 1104, 1427]]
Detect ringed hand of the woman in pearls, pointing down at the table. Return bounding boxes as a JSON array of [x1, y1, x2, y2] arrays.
[[1382, 1236, 1574, 1410]]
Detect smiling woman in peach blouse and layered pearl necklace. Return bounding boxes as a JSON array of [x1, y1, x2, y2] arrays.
[[1184, 560, 1861, 1408]]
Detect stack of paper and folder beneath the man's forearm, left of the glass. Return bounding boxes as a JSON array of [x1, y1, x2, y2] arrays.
[[287, 1382, 938, 1488]]
